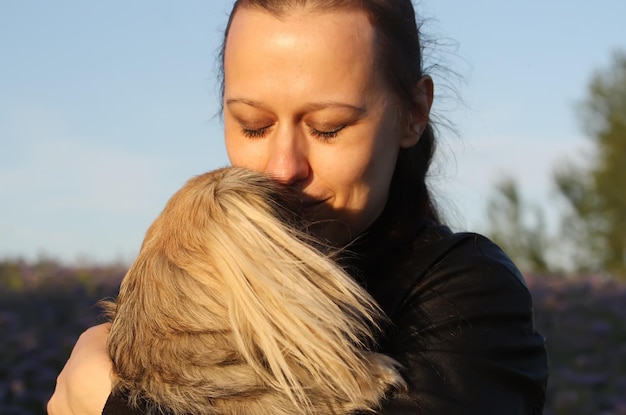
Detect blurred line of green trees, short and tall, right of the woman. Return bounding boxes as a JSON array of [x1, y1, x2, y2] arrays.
[[487, 51, 626, 279]]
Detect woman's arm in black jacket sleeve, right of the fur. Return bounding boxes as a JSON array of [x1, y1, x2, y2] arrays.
[[387, 236, 548, 415]]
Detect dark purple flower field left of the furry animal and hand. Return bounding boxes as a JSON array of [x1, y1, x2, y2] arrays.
[[0, 261, 125, 415]]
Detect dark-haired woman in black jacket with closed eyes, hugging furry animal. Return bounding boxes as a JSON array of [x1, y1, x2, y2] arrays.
[[49, 0, 548, 415]]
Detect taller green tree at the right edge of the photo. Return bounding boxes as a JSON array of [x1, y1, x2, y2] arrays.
[[554, 53, 626, 278]]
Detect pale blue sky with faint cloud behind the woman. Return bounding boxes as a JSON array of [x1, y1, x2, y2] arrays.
[[0, 0, 626, 262]]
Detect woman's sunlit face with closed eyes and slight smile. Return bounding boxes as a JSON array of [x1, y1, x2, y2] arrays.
[[224, 8, 418, 243]]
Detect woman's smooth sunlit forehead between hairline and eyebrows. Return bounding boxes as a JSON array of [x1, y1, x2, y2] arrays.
[[224, 8, 378, 98]]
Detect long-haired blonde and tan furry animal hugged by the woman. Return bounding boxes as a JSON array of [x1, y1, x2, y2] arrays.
[[103, 168, 404, 415]]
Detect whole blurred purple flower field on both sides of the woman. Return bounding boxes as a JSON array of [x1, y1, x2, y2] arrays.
[[0, 260, 626, 415]]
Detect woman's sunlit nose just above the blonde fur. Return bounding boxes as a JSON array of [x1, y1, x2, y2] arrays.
[[265, 127, 311, 185]]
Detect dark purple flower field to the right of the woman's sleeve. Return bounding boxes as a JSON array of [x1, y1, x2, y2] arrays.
[[526, 275, 626, 415]]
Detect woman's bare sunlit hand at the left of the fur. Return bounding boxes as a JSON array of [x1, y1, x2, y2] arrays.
[[48, 323, 112, 415]]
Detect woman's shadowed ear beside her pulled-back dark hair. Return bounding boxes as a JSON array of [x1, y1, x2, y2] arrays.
[[400, 75, 435, 148]]
